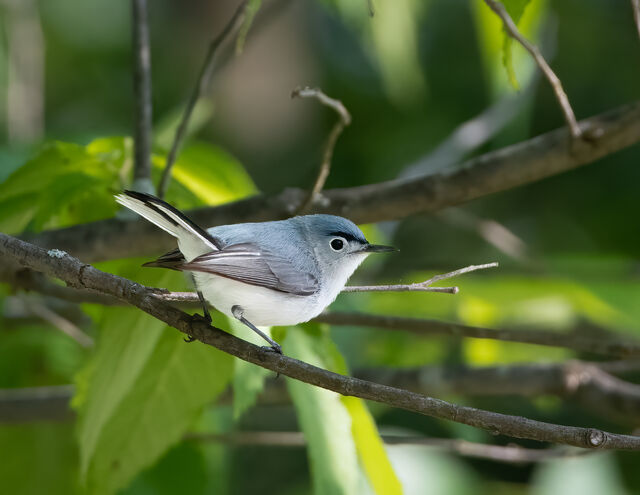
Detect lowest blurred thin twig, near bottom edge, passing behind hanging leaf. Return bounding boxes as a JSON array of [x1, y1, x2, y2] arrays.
[[185, 431, 591, 464]]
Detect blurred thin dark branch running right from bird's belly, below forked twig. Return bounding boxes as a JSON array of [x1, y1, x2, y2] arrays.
[[314, 312, 640, 357]]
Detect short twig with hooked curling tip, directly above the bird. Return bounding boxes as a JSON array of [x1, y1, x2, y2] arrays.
[[291, 87, 351, 215]]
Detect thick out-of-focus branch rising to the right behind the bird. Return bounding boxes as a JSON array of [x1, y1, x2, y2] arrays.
[[18, 102, 640, 262]]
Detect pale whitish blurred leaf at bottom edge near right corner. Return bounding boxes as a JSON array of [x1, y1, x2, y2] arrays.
[[531, 453, 629, 495]]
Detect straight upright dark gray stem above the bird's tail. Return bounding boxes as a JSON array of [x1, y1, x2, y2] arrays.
[[131, 0, 153, 192]]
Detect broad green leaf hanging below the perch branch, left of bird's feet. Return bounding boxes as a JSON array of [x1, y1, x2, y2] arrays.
[[78, 271, 232, 494]]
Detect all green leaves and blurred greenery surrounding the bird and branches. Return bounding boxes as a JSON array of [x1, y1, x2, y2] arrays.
[[0, 0, 640, 495]]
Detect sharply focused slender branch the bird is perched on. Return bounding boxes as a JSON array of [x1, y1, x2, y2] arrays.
[[0, 233, 640, 450]]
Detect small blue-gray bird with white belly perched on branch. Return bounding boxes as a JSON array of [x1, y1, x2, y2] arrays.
[[116, 191, 395, 353]]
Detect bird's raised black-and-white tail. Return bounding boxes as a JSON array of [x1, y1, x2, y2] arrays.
[[116, 191, 220, 258]]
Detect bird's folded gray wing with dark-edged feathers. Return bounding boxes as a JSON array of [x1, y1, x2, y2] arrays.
[[178, 243, 320, 296]]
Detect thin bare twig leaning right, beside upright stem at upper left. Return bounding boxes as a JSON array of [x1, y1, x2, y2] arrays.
[[158, 0, 247, 198]]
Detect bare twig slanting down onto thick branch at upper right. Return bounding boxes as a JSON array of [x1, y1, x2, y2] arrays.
[[484, 0, 582, 138]]
